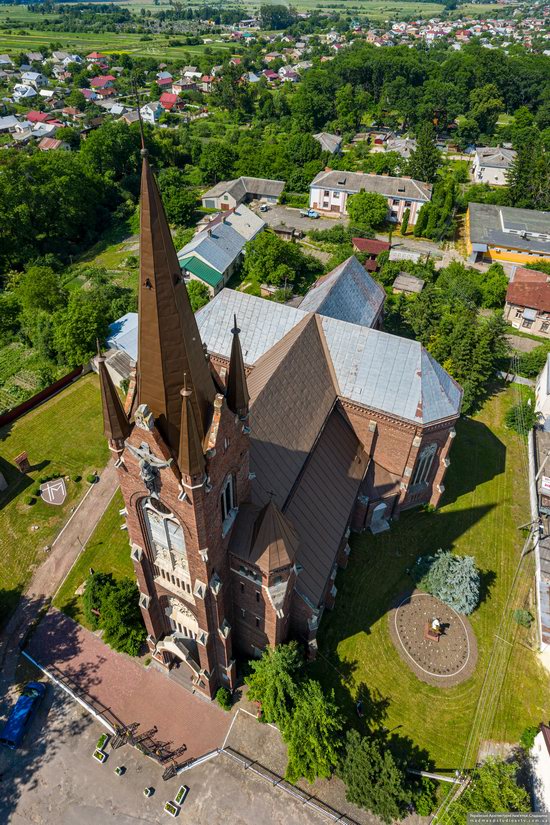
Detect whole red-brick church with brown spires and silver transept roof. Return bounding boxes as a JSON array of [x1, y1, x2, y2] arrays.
[[99, 150, 461, 697]]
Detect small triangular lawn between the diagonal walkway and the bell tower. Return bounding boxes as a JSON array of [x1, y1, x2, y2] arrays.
[[53, 490, 134, 627]]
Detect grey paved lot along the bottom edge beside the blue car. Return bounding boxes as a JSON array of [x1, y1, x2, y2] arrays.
[[0, 686, 338, 825]]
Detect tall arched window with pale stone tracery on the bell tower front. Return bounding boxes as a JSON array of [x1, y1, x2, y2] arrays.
[[142, 499, 193, 600]]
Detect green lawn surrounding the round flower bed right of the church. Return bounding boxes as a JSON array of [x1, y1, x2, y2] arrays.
[[312, 387, 550, 770]]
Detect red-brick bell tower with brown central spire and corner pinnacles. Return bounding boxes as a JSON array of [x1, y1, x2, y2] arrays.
[[99, 149, 249, 698]]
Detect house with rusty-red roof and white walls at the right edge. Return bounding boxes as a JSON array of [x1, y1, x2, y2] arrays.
[[504, 267, 550, 338]]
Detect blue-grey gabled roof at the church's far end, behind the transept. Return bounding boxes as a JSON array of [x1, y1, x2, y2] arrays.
[[300, 255, 386, 327]]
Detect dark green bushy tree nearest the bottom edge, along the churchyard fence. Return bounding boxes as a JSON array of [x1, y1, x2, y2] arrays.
[[338, 730, 410, 822]]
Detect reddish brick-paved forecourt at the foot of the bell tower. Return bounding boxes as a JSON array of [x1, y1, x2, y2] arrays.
[[28, 608, 231, 761]]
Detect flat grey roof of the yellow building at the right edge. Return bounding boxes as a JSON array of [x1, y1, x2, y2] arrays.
[[469, 203, 550, 255]]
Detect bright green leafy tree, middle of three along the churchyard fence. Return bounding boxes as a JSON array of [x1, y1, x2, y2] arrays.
[[283, 680, 343, 782]]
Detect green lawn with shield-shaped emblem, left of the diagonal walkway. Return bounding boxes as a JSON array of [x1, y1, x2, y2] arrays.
[[0, 375, 109, 624]]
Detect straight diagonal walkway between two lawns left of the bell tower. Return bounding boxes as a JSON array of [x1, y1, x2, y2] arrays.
[[0, 461, 118, 694]]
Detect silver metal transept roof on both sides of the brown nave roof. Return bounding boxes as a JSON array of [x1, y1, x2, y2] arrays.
[[196, 289, 462, 424]]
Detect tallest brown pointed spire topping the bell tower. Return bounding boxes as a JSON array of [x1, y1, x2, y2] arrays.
[[138, 149, 215, 455]]
